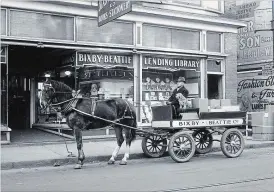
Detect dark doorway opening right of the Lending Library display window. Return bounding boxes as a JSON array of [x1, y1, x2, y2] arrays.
[[207, 74, 223, 99]]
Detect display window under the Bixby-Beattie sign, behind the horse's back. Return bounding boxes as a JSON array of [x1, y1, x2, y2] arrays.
[[79, 66, 134, 102]]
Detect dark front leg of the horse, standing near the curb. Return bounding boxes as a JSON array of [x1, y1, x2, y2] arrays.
[[74, 127, 85, 169]]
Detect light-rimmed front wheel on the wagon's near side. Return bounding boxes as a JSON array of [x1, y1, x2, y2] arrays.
[[168, 131, 195, 163]]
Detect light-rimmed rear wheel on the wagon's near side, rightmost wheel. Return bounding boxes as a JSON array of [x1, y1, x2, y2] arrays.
[[221, 128, 245, 158]]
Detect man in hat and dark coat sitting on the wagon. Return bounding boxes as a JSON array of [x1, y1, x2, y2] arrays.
[[167, 77, 189, 117]]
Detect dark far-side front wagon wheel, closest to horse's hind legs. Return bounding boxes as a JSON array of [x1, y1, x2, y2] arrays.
[[142, 135, 167, 158]]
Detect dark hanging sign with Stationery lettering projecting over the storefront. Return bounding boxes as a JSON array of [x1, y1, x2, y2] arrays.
[[98, 0, 132, 27]]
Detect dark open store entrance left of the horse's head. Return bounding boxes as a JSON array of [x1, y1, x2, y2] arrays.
[[8, 46, 74, 130]]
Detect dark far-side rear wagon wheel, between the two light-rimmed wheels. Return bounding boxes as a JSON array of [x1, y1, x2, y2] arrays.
[[192, 129, 213, 154]]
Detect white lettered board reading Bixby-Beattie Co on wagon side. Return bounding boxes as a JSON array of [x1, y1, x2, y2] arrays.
[[172, 119, 243, 128]]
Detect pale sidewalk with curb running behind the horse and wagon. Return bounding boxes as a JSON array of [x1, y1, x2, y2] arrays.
[[1, 135, 274, 170]]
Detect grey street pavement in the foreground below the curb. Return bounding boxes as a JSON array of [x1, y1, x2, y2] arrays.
[[1, 148, 274, 192]]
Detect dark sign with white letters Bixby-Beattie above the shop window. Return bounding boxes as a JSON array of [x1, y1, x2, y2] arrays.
[[77, 52, 133, 67]]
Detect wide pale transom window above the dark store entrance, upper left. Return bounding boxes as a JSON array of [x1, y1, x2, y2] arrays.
[[10, 10, 74, 40]]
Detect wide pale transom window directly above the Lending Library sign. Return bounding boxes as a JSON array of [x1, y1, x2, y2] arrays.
[[142, 25, 200, 50]]
